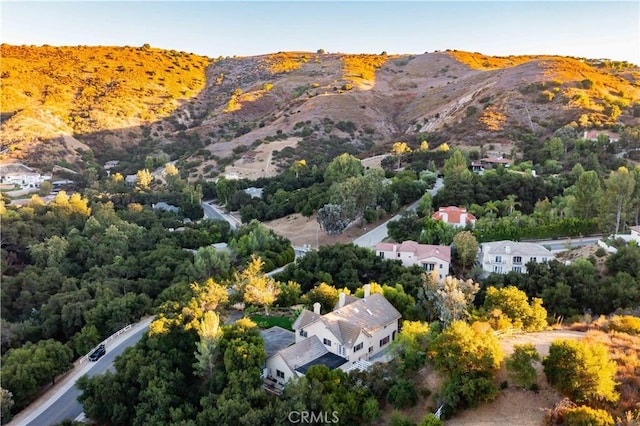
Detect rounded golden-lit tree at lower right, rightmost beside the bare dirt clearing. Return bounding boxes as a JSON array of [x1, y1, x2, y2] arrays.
[[542, 339, 619, 403]]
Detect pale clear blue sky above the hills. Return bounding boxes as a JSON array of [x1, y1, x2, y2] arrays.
[[0, 0, 640, 64]]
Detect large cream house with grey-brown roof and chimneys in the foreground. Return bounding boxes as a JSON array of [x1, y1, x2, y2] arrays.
[[263, 285, 401, 389]]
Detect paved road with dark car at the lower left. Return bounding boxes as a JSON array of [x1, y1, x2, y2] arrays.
[[9, 317, 153, 426]]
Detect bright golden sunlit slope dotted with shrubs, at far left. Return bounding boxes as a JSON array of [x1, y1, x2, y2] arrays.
[[0, 44, 209, 162]]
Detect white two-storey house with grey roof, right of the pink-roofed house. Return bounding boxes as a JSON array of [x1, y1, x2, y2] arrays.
[[479, 240, 555, 275]]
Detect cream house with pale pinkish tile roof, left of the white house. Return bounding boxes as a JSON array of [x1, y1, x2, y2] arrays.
[[376, 241, 451, 280]]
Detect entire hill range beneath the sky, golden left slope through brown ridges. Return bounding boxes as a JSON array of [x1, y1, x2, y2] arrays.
[[1, 44, 640, 177]]
